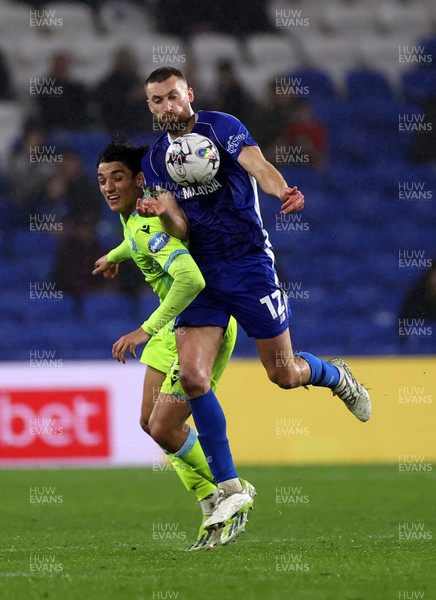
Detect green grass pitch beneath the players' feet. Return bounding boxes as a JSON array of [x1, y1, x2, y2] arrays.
[[0, 465, 436, 600]]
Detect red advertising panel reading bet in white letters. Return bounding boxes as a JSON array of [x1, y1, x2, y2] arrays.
[[0, 388, 110, 460]]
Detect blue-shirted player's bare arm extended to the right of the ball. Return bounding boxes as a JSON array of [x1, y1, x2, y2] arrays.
[[238, 146, 304, 214]]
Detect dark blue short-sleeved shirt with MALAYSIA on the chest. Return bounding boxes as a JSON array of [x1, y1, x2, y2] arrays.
[[142, 111, 271, 265]]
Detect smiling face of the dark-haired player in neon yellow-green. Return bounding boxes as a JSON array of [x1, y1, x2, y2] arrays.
[[97, 161, 143, 216]]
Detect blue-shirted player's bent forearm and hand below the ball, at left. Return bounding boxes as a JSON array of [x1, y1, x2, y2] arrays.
[[136, 190, 189, 241]]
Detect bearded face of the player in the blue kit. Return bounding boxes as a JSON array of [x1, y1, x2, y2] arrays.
[[145, 75, 194, 131]]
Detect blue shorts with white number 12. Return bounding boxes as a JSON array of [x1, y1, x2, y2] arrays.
[[175, 248, 290, 339]]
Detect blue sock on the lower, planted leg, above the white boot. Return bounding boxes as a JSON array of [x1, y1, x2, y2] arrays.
[[189, 390, 238, 483]]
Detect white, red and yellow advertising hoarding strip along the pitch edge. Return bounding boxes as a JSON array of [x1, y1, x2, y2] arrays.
[[0, 357, 436, 472]]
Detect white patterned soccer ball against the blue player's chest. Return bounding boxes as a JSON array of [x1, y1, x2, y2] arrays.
[[165, 133, 220, 186]]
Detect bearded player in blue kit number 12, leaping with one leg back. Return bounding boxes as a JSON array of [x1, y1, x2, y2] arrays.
[[137, 67, 371, 527]]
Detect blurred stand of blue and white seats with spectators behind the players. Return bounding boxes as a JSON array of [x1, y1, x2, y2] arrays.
[[0, 0, 436, 361]]
